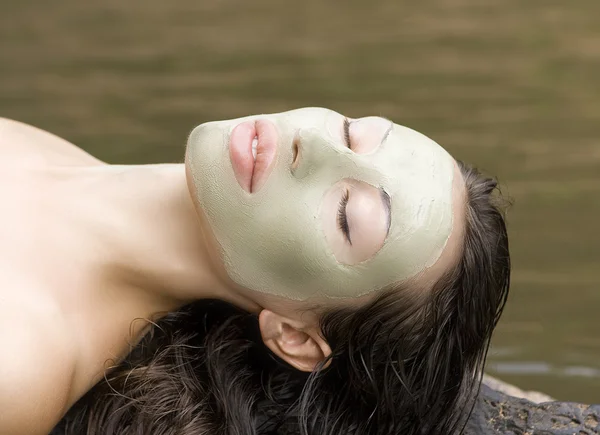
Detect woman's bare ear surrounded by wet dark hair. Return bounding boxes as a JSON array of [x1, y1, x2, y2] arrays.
[[258, 310, 331, 372]]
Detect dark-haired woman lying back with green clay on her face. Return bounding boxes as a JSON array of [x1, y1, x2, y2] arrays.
[[0, 109, 510, 434]]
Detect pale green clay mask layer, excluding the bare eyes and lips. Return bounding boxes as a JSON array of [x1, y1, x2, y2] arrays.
[[186, 108, 454, 300]]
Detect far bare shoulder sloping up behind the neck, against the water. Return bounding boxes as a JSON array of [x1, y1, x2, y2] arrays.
[[0, 117, 101, 166]]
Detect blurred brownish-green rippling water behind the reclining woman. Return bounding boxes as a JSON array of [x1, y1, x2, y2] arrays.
[[0, 0, 600, 403]]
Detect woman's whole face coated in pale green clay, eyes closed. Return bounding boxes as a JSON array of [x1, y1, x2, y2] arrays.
[[186, 108, 464, 300]]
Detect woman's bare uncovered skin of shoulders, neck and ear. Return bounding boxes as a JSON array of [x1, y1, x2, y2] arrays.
[[0, 119, 464, 435]]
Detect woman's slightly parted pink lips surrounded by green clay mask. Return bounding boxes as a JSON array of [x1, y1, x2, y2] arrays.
[[229, 119, 277, 193]]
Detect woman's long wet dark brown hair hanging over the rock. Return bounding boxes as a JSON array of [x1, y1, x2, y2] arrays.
[[56, 162, 510, 435]]
